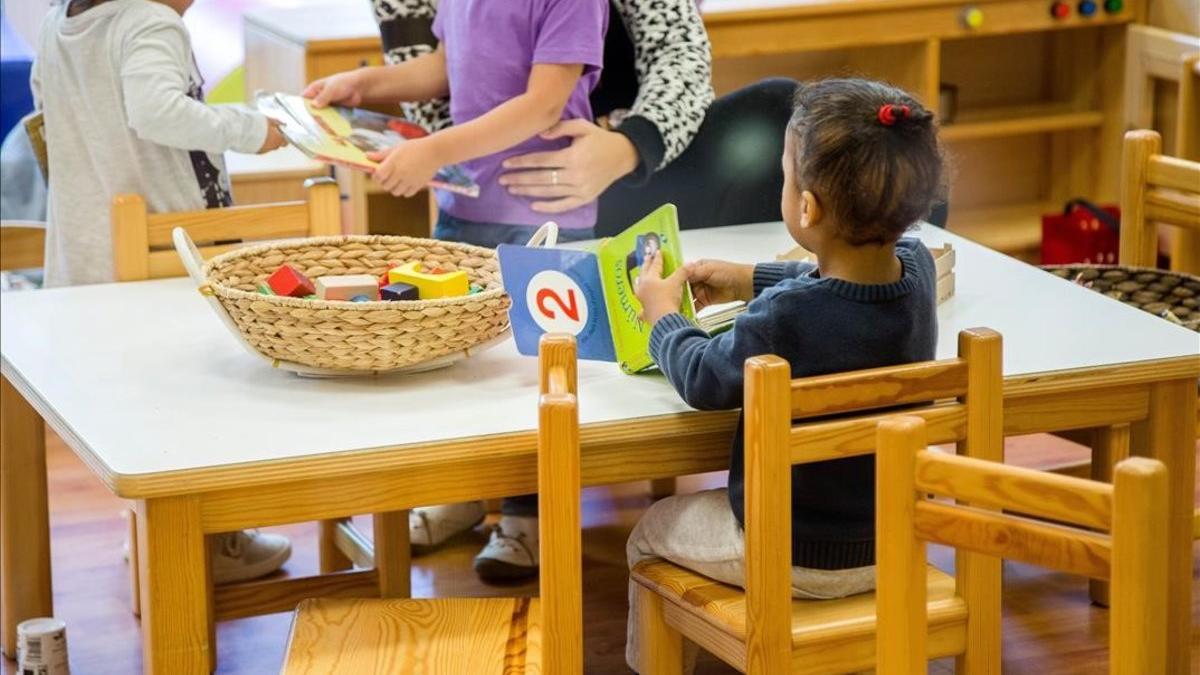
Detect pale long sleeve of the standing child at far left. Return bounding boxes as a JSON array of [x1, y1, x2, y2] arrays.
[[121, 14, 271, 153]]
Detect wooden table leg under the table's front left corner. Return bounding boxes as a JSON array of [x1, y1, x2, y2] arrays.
[[137, 497, 216, 675]]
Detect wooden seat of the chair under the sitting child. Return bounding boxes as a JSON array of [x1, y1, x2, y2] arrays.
[[631, 558, 967, 673]]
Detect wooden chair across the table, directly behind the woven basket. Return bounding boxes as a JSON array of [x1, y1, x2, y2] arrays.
[[112, 178, 410, 629]]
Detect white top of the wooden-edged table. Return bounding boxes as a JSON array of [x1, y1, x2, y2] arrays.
[[0, 223, 1200, 477]]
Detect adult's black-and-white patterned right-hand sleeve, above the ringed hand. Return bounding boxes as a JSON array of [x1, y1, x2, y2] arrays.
[[613, 0, 713, 171]]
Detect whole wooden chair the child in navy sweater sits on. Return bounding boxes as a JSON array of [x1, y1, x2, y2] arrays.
[[631, 329, 1003, 675]]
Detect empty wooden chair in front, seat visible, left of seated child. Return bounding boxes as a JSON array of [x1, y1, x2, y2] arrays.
[[282, 335, 583, 675]]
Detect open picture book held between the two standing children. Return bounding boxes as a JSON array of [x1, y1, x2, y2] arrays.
[[254, 91, 479, 197]]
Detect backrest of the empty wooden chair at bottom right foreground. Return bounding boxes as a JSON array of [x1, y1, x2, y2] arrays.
[[875, 417, 1168, 675]]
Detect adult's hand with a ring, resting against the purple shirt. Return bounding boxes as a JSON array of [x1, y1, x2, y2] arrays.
[[500, 119, 637, 214]]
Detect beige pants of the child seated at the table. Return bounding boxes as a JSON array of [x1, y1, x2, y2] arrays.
[[625, 488, 875, 674]]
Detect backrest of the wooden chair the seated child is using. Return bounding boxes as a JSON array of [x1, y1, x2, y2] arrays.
[[744, 328, 1003, 674]]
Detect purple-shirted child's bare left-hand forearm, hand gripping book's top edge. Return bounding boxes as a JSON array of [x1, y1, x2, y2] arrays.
[[304, 46, 450, 108]]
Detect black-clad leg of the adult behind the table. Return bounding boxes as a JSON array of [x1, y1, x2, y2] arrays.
[[596, 78, 796, 237]]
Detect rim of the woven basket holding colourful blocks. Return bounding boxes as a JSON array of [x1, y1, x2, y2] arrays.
[[203, 234, 506, 312]]
